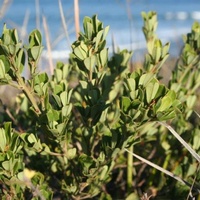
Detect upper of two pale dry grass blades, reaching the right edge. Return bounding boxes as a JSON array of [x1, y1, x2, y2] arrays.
[[158, 122, 200, 163]]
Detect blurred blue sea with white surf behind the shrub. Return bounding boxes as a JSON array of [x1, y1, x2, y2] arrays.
[[0, 0, 200, 59]]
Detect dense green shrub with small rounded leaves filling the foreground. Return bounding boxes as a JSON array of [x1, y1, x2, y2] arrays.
[[0, 12, 200, 199]]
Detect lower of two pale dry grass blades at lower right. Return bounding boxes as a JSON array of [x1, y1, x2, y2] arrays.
[[125, 148, 200, 192]]
